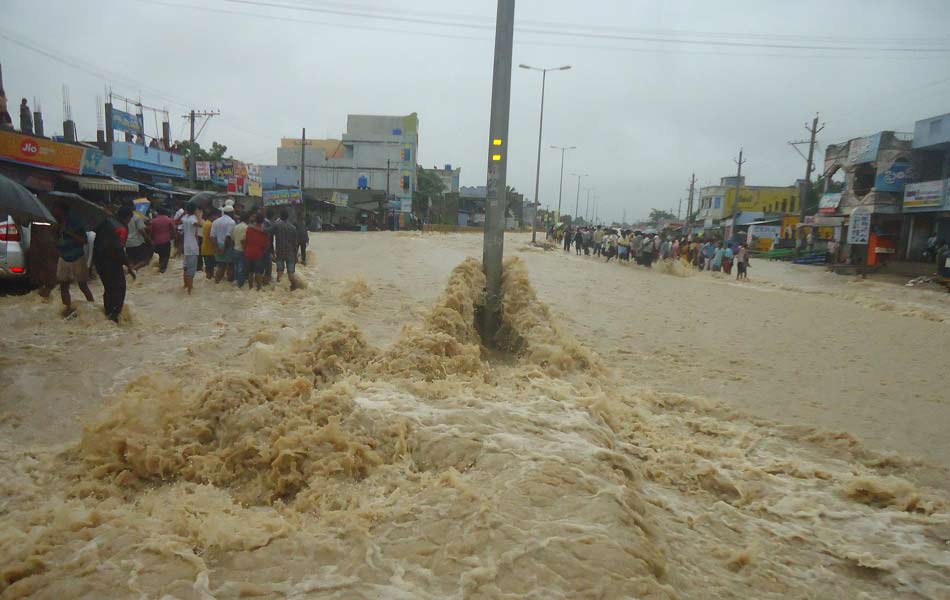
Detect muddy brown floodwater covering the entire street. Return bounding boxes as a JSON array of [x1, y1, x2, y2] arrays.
[[0, 234, 950, 600]]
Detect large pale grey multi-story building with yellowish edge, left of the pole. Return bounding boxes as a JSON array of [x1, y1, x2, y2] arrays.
[[277, 113, 419, 213]]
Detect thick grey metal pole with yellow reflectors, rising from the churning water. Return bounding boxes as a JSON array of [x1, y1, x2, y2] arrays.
[[481, 0, 515, 343]]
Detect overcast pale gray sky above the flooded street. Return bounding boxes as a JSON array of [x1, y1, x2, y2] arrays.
[[0, 0, 950, 219]]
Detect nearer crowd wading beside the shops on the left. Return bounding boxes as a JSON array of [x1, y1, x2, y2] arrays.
[[40, 199, 310, 322]]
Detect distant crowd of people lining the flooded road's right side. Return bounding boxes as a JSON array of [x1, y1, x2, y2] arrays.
[[547, 226, 750, 279]]
